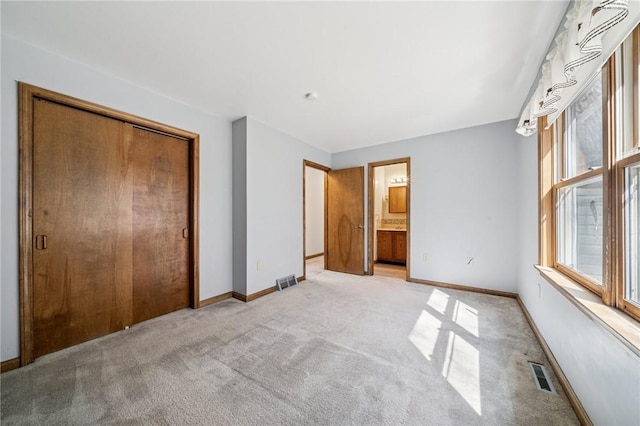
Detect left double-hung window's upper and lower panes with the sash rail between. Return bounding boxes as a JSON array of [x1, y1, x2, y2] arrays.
[[554, 74, 604, 291]]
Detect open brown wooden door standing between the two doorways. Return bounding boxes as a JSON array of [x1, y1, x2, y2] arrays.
[[326, 167, 364, 275]]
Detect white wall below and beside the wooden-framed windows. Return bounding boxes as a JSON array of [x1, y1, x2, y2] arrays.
[[515, 135, 640, 425]]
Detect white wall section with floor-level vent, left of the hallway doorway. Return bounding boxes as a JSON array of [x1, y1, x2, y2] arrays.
[[246, 117, 331, 295]]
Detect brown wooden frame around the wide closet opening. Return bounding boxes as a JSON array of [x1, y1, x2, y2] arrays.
[[18, 82, 200, 366]]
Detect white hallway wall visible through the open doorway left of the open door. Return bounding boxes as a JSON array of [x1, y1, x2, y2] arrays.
[[305, 166, 325, 256]]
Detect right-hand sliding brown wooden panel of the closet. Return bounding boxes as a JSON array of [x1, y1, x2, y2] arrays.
[[132, 128, 189, 323]]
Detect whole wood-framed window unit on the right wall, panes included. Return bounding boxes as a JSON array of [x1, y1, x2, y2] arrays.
[[538, 27, 640, 320]]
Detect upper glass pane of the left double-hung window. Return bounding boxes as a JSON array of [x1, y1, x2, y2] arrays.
[[564, 74, 602, 178]]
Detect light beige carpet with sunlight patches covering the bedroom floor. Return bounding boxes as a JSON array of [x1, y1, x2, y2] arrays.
[[0, 268, 578, 425]]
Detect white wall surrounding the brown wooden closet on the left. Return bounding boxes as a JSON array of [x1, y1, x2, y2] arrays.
[[0, 35, 234, 361]]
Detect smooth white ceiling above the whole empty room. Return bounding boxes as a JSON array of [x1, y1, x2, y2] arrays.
[[1, 0, 568, 152]]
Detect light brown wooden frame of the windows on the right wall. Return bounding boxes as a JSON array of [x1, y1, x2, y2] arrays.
[[538, 25, 640, 321]]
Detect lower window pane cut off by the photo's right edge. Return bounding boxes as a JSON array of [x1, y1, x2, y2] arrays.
[[624, 164, 640, 305]]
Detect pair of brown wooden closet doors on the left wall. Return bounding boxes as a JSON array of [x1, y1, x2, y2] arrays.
[[32, 99, 189, 357]]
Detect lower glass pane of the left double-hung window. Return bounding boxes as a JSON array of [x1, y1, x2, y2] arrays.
[[556, 178, 603, 285]]
